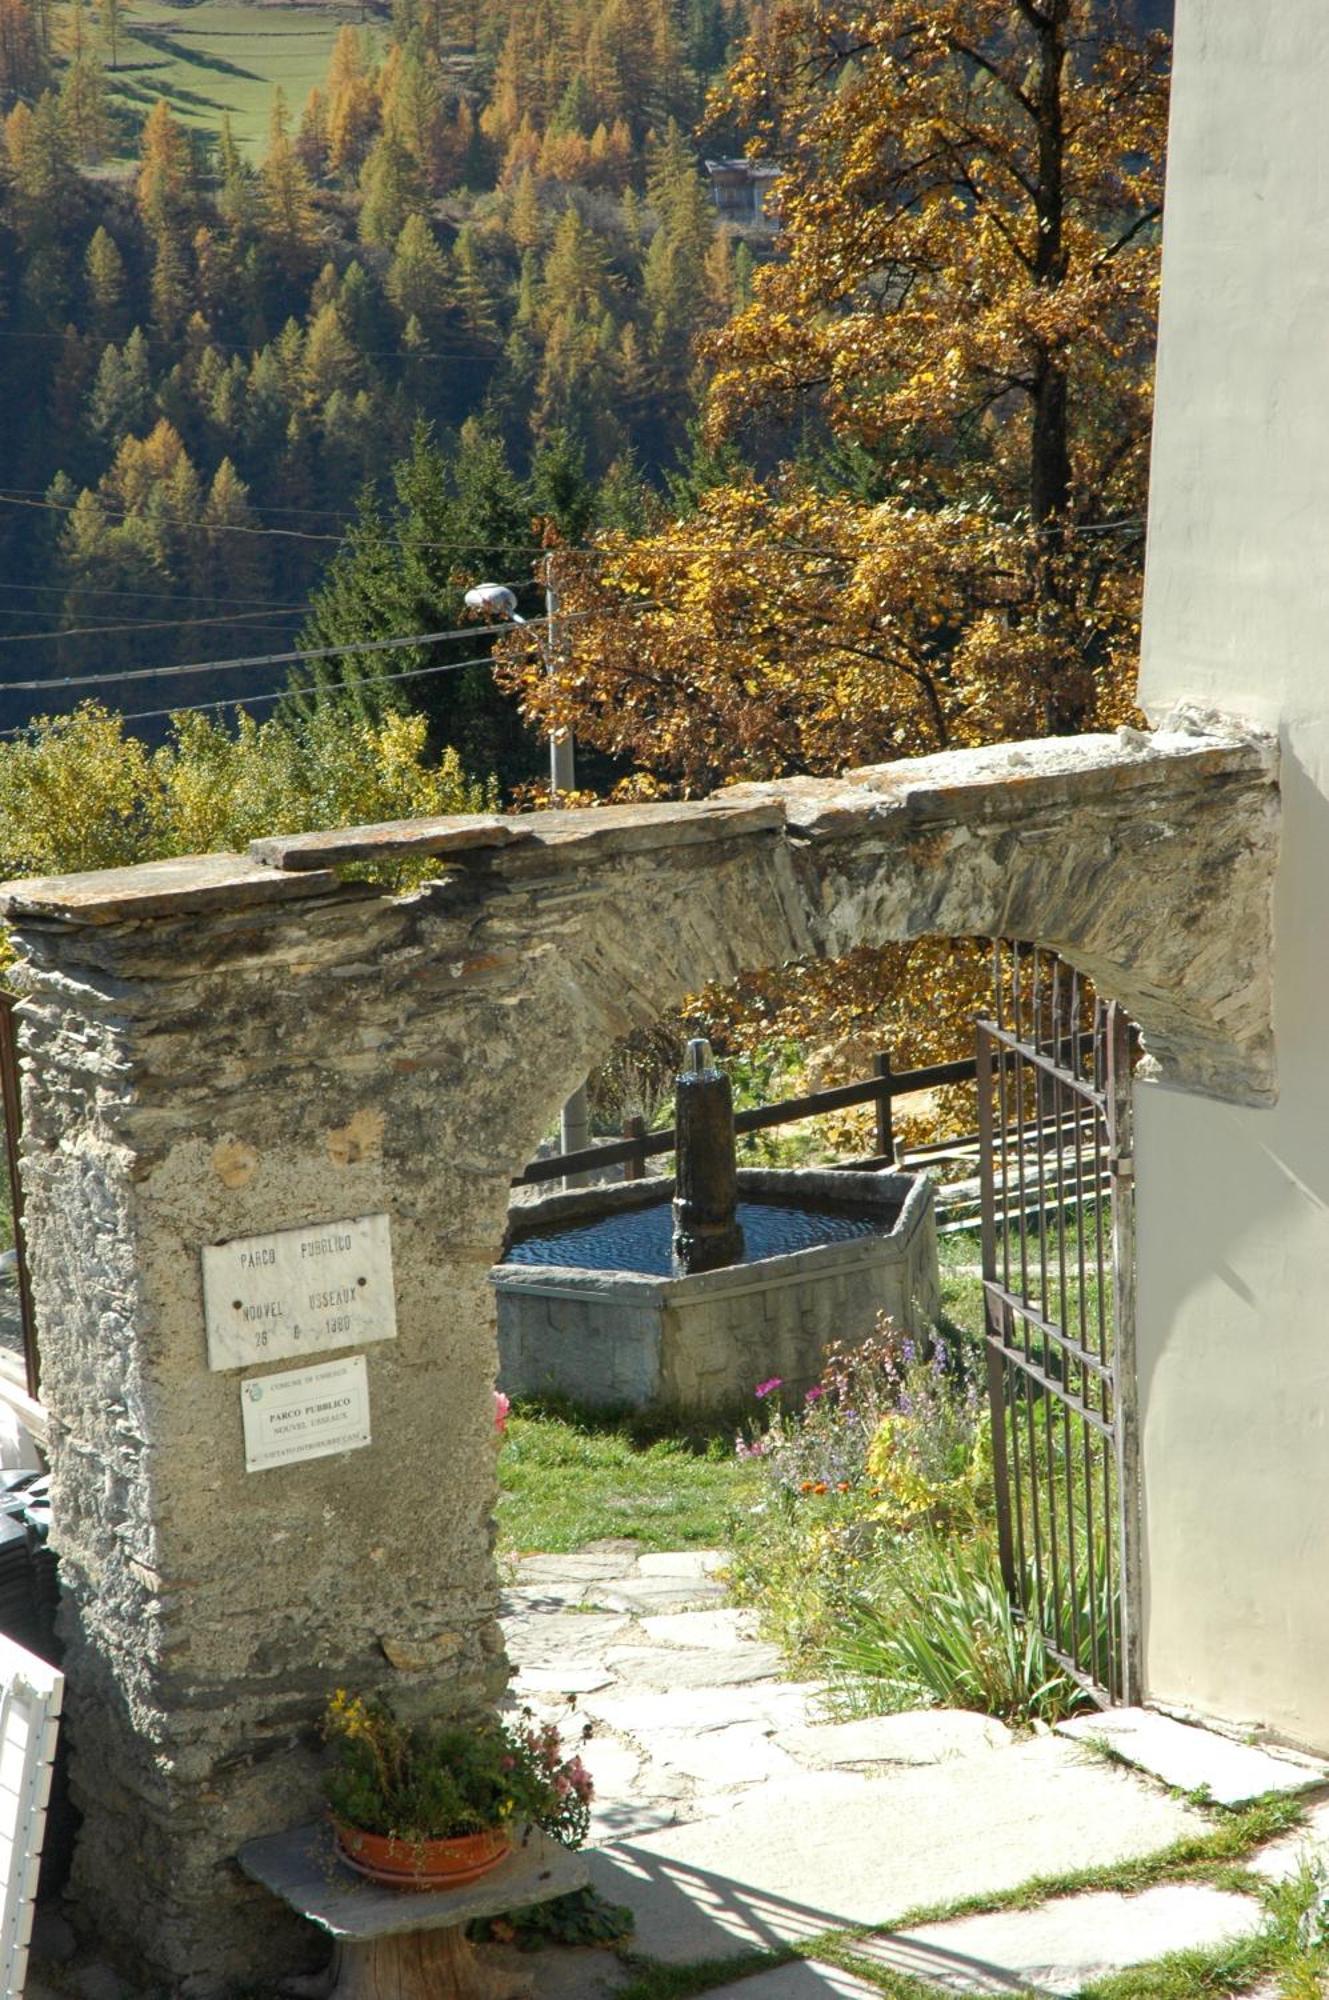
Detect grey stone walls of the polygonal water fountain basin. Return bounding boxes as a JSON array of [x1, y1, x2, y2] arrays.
[[490, 1168, 941, 1412]]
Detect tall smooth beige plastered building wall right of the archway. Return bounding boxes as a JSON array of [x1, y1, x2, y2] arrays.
[[1137, 0, 1329, 1750]]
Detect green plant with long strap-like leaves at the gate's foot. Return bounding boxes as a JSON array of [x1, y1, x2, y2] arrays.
[[831, 1536, 1087, 1722]]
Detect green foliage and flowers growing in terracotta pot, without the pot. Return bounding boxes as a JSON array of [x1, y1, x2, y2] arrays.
[[324, 1690, 592, 1848]]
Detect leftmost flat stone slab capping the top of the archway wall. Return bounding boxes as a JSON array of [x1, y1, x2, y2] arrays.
[[0, 854, 340, 924]]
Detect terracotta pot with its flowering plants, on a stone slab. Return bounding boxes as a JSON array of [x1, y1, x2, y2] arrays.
[[324, 1690, 592, 1888]]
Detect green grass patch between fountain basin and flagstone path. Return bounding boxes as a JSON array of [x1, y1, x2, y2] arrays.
[[498, 1412, 759, 1554]]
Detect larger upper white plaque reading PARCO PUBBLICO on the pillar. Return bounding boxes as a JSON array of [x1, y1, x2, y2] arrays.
[[202, 1216, 396, 1368]]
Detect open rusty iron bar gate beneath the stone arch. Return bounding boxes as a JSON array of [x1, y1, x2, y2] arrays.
[[979, 944, 1141, 1702]]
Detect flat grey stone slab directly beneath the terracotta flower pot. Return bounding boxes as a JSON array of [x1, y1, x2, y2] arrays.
[[236, 1820, 588, 1938]]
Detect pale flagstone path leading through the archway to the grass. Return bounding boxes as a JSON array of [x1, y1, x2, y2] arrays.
[[490, 1542, 1329, 2000]]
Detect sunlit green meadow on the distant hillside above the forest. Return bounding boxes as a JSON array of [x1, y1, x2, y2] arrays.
[[92, 0, 374, 158]]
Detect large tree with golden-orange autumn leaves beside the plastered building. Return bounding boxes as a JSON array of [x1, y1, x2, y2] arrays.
[[504, 0, 1167, 790]]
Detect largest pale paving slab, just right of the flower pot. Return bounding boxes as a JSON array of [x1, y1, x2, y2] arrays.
[[588, 1736, 1211, 1962]]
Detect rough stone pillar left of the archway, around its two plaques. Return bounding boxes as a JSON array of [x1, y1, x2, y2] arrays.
[[3, 860, 510, 1994]]
